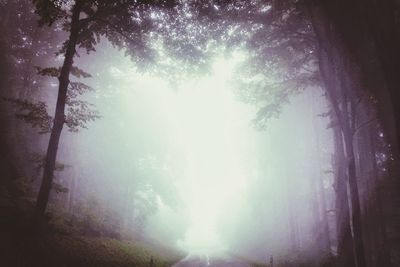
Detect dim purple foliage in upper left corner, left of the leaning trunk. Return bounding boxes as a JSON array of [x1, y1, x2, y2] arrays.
[[0, 0, 62, 101]]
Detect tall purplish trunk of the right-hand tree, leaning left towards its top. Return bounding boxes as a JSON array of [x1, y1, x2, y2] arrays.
[[310, 3, 365, 267]]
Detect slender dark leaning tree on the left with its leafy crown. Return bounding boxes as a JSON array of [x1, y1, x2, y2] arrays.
[[33, 0, 175, 221]]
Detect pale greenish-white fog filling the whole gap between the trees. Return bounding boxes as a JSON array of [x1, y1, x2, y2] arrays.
[[47, 45, 335, 261]]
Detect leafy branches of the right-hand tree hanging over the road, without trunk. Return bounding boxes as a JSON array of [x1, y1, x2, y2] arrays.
[[189, 0, 320, 129]]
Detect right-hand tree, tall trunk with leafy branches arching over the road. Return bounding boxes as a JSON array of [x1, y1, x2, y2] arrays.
[[197, 0, 382, 266]]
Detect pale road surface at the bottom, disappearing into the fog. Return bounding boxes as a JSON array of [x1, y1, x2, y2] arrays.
[[172, 255, 250, 267]]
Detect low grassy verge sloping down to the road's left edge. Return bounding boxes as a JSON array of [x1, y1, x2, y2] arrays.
[[0, 230, 183, 267]]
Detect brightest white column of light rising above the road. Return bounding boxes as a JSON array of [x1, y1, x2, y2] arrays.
[[169, 55, 253, 251]]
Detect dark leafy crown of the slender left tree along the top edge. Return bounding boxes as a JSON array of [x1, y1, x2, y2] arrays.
[[33, 0, 177, 64]]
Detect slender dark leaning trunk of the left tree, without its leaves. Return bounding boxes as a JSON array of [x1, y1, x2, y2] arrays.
[[35, 1, 82, 219]]
